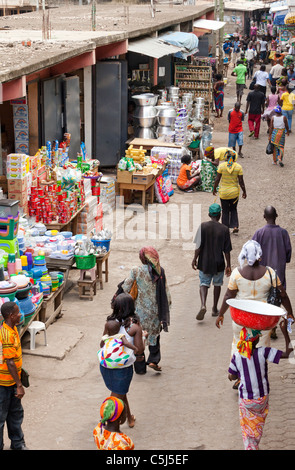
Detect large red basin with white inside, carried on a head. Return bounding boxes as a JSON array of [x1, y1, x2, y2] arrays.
[[226, 299, 285, 330]]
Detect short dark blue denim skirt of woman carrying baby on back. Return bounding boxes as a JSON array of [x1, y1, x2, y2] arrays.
[[100, 365, 133, 395]]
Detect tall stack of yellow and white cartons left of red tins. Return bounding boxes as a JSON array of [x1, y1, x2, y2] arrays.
[[6, 153, 30, 214]]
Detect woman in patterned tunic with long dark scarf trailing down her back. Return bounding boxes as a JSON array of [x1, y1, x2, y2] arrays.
[[122, 246, 171, 374]]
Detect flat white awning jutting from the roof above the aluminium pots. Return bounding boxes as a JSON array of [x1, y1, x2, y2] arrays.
[[128, 38, 183, 59]]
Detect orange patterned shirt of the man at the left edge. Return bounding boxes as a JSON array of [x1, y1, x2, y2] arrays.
[[0, 322, 22, 387]]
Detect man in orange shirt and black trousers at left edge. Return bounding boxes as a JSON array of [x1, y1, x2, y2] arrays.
[[0, 302, 27, 450]]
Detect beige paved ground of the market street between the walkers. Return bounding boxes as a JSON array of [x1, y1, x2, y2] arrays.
[[12, 66, 295, 450]]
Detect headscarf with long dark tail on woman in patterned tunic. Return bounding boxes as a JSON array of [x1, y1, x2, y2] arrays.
[[139, 246, 170, 331]]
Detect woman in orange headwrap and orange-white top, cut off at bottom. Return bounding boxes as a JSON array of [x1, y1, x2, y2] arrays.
[[93, 396, 134, 450]]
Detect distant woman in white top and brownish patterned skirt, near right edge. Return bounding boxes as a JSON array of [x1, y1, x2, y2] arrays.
[[269, 106, 289, 166]]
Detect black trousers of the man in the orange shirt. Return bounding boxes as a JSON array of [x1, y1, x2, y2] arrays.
[[0, 385, 25, 450]]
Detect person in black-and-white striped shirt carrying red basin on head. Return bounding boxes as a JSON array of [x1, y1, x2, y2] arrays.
[[228, 319, 293, 450]]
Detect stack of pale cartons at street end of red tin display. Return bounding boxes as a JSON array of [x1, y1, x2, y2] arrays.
[[77, 196, 103, 237]]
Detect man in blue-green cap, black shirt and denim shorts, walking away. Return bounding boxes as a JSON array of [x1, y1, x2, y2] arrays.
[[192, 204, 232, 320]]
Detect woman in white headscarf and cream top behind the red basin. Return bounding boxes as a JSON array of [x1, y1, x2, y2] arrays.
[[216, 240, 294, 380]]
